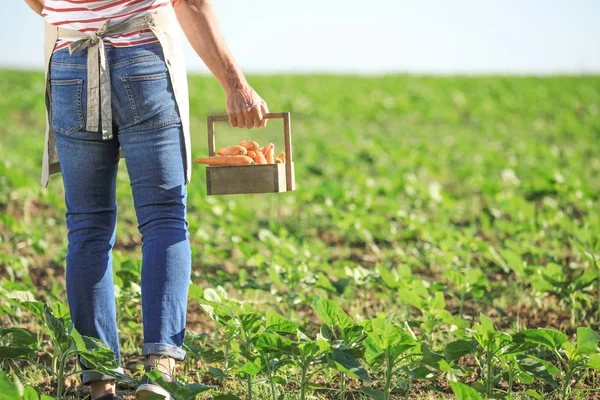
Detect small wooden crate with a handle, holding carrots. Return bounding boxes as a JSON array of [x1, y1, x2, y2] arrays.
[[206, 112, 295, 195]]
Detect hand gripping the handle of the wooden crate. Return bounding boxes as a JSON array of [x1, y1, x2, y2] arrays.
[[226, 85, 269, 129]]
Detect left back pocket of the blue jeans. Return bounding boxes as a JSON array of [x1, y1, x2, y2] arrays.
[[50, 79, 85, 135]]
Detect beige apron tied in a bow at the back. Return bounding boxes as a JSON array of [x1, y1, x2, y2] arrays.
[[42, 5, 192, 186]]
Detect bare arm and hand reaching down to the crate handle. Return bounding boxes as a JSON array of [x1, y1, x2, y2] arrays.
[[172, 0, 269, 128]]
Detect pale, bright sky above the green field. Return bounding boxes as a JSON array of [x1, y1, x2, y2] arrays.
[[0, 0, 600, 75]]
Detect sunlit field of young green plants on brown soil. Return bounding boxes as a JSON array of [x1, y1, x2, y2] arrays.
[[0, 71, 600, 400]]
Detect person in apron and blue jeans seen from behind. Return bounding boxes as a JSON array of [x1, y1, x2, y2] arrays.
[[25, 0, 268, 400]]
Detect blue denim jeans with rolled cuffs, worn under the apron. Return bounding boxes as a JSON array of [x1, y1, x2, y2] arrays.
[[50, 43, 191, 384]]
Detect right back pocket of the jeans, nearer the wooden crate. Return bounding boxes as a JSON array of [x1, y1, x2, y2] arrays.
[[121, 72, 181, 128]]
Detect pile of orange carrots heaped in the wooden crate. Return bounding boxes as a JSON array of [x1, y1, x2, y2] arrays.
[[194, 140, 285, 166]]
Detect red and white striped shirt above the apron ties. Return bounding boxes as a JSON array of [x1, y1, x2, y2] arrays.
[[42, 0, 171, 51]]
